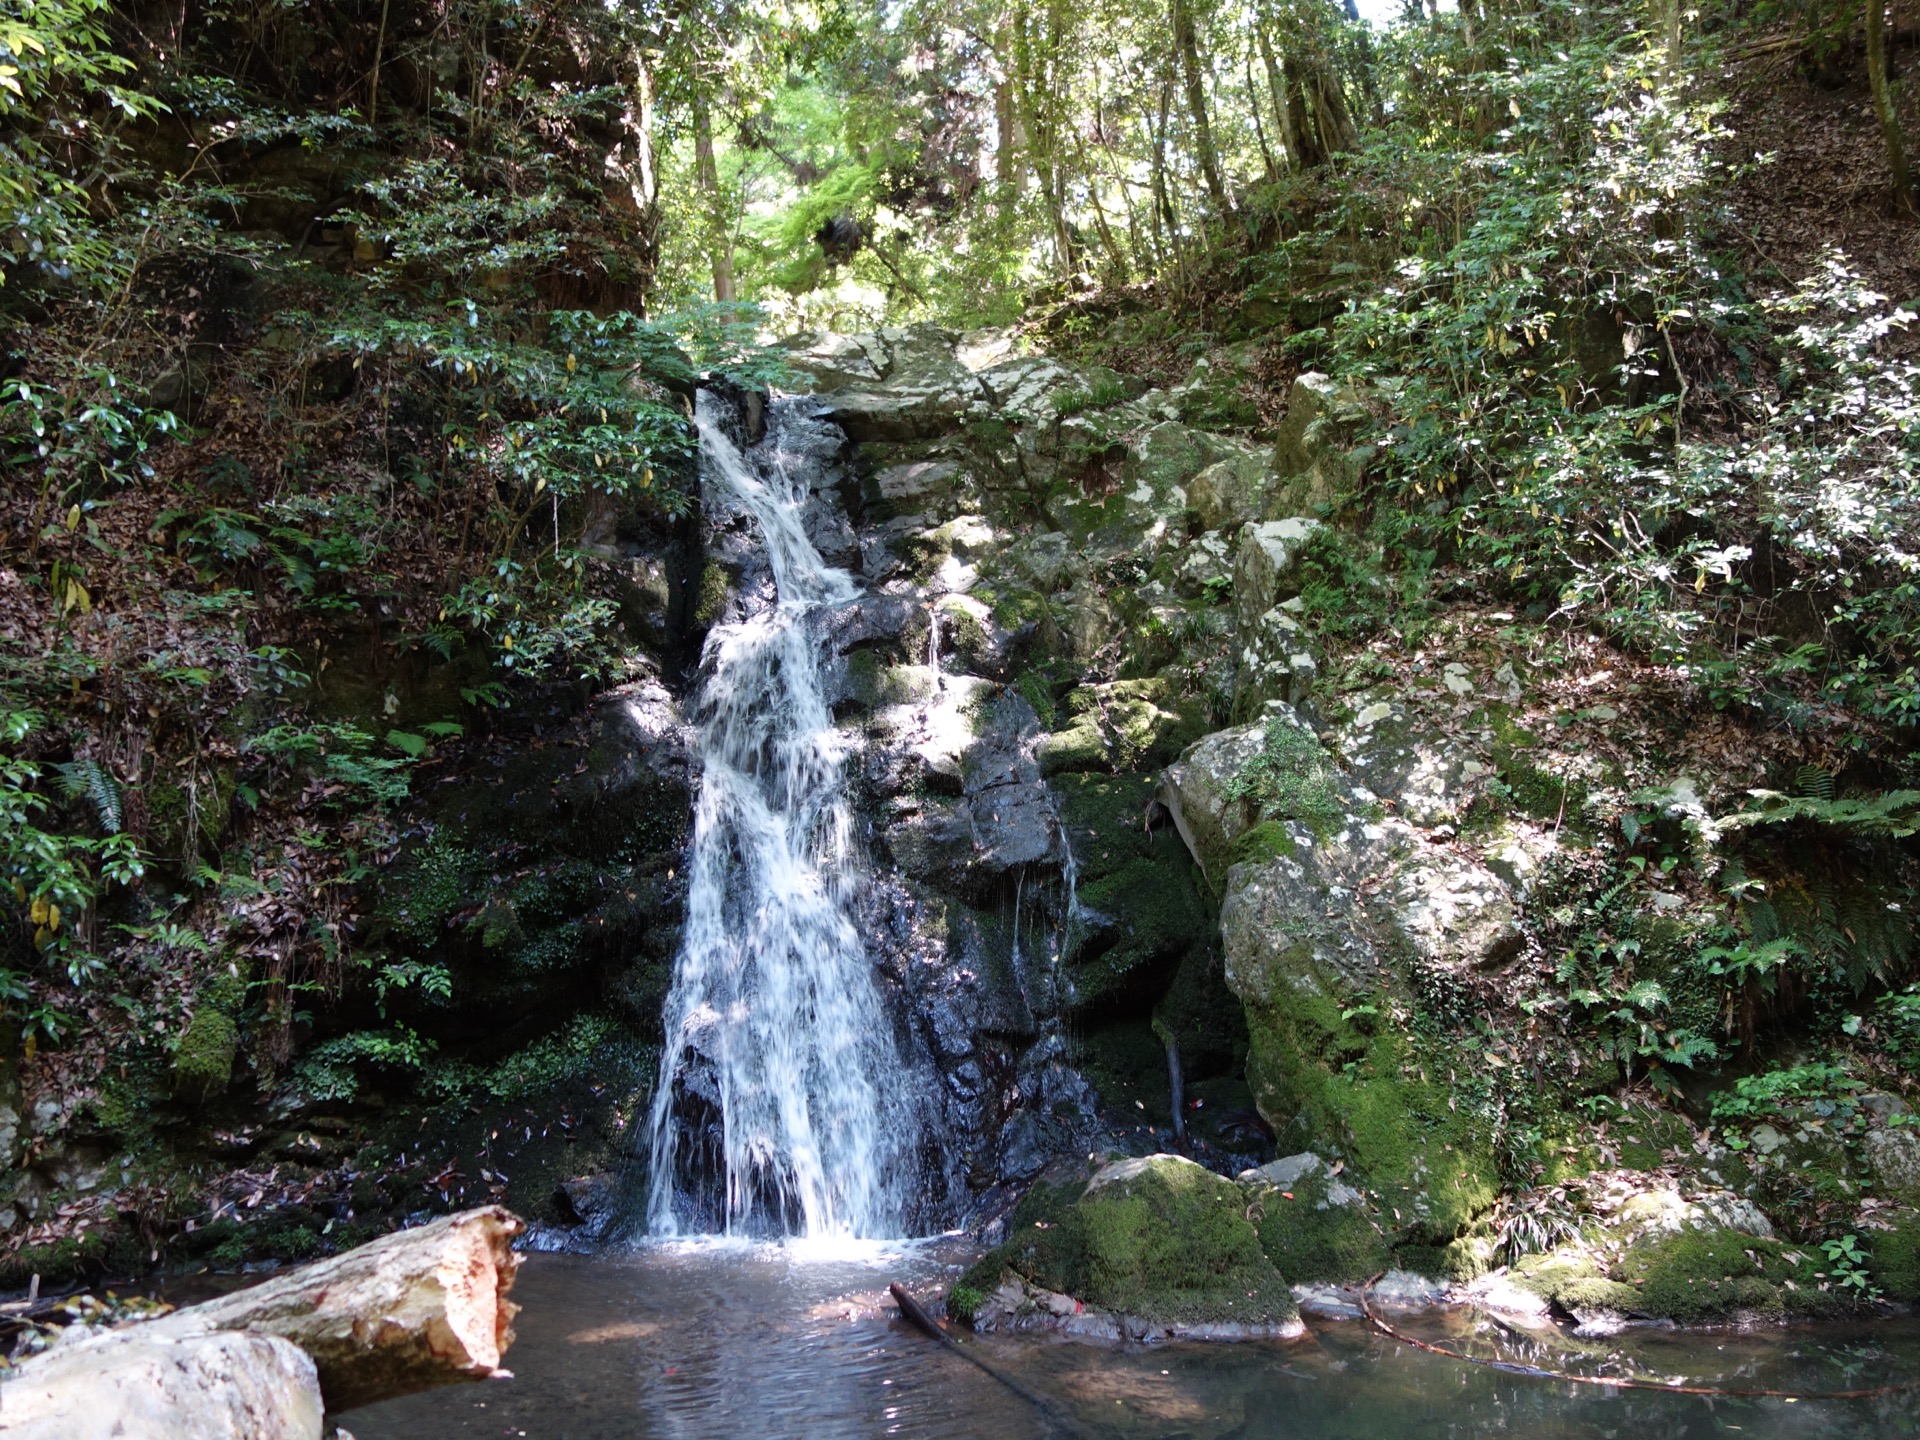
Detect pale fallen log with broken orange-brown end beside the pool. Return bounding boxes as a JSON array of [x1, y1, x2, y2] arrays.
[[0, 1206, 524, 1440]]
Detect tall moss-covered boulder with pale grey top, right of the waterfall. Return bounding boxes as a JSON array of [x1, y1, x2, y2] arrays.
[[1162, 705, 1521, 1269]]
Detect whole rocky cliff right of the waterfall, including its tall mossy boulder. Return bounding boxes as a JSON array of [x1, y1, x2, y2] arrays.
[[771, 326, 1489, 1228]]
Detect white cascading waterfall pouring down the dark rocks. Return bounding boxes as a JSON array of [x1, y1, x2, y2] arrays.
[[647, 392, 918, 1236]]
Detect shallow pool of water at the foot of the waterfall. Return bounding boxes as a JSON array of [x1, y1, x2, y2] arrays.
[[346, 1244, 1920, 1440]]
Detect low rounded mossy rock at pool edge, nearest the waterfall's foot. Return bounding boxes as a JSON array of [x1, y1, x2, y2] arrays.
[[954, 1156, 1298, 1331]]
